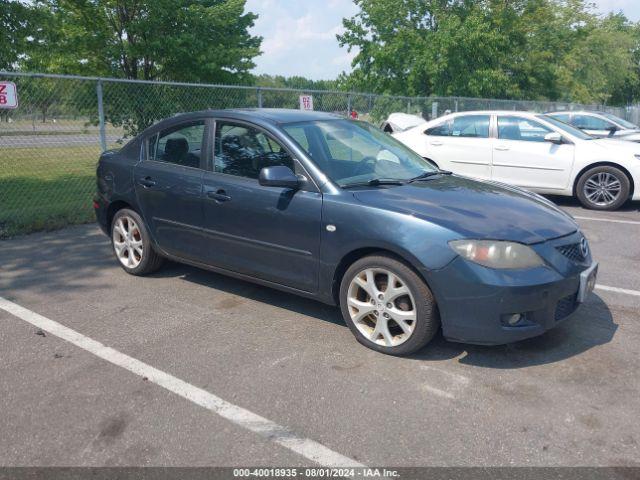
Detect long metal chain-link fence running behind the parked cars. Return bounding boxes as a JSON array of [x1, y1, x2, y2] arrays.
[[0, 72, 637, 238]]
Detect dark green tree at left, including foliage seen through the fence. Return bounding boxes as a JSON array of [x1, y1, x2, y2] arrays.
[[13, 0, 262, 135]]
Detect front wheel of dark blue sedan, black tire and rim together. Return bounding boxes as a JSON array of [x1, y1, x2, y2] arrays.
[[340, 255, 440, 355]]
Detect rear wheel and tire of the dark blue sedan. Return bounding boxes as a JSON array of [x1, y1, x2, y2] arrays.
[[111, 208, 164, 275]]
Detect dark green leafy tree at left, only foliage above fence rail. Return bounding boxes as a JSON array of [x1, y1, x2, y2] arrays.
[[32, 0, 261, 83]]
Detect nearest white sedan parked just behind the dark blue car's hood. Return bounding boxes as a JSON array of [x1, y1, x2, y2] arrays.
[[393, 111, 640, 210]]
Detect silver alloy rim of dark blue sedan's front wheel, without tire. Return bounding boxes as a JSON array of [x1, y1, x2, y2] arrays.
[[347, 268, 417, 347]]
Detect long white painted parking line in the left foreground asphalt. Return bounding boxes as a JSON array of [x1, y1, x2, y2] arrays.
[[0, 297, 364, 467]]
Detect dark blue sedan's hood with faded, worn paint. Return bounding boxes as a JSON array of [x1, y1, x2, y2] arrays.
[[354, 175, 578, 244]]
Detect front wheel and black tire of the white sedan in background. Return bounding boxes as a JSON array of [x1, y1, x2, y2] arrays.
[[576, 165, 631, 210]]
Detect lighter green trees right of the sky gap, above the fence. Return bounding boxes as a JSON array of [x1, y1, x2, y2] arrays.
[[337, 0, 640, 104]]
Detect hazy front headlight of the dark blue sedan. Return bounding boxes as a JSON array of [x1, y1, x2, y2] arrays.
[[449, 240, 544, 268]]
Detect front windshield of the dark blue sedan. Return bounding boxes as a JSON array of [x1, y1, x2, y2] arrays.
[[283, 120, 437, 187]]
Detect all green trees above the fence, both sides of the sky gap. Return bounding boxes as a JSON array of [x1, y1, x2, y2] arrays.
[[0, 0, 640, 109]]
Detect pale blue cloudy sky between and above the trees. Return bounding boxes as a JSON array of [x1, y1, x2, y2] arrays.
[[247, 0, 640, 80]]
